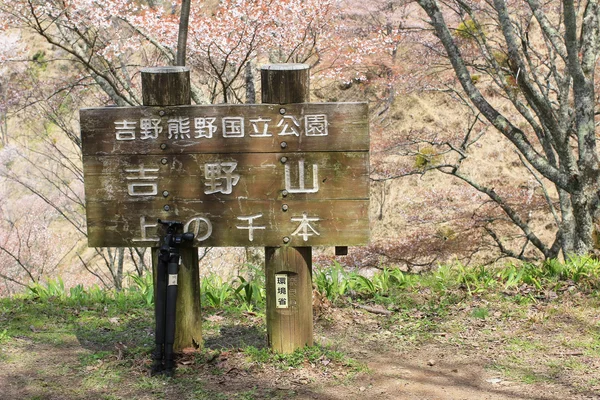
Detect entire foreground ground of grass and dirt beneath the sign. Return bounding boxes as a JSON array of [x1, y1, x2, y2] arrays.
[[0, 260, 600, 400]]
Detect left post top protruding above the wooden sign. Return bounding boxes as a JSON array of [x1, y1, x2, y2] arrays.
[[141, 66, 191, 106]]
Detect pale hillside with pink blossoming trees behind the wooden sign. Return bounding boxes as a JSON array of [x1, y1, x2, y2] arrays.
[[0, 0, 592, 294]]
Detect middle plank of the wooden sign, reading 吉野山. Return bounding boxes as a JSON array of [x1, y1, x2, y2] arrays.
[[84, 152, 369, 203]]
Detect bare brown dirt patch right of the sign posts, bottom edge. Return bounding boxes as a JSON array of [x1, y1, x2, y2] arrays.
[[316, 346, 592, 400]]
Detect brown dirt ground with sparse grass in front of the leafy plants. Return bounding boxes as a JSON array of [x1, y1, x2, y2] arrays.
[[0, 299, 600, 400]]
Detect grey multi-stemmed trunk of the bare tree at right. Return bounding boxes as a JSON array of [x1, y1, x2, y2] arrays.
[[418, 0, 600, 257]]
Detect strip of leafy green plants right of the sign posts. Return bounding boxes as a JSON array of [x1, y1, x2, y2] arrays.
[[313, 257, 600, 309]]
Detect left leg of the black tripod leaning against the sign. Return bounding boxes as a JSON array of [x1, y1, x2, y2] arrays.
[[151, 254, 167, 375]]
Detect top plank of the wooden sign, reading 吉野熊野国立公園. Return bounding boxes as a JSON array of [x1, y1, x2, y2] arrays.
[[80, 103, 369, 155]]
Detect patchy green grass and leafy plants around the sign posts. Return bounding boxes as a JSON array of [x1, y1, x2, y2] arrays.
[[0, 257, 600, 399]]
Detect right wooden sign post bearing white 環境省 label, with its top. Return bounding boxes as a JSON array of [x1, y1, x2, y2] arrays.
[[261, 64, 313, 353]]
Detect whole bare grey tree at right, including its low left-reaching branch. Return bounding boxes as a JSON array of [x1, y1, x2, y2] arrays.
[[408, 0, 600, 258]]
